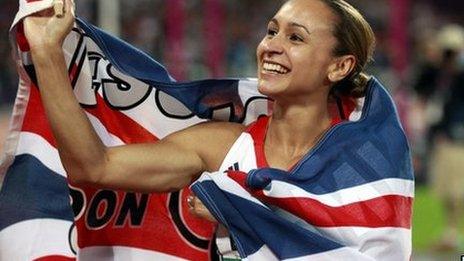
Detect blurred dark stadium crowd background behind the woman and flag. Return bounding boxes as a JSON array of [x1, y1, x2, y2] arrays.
[[0, 0, 464, 260]]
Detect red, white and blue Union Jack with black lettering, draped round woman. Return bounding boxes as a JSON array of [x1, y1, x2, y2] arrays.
[[0, 0, 414, 260]]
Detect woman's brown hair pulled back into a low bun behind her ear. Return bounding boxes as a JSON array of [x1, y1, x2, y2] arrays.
[[320, 0, 375, 97]]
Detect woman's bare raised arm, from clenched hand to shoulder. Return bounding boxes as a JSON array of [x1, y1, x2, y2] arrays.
[[24, 0, 242, 192]]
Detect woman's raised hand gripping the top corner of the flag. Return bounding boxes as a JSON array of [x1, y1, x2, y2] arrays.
[[23, 0, 74, 50]]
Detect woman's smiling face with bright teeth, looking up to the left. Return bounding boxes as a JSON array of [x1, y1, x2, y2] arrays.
[[257, 0, 337, 98]]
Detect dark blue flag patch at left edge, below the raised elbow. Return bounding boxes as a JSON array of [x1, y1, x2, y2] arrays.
[[0, 154, 74, 230]]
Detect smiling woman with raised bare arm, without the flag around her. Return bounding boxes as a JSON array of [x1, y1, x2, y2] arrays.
[[24, 0, 412, 258]]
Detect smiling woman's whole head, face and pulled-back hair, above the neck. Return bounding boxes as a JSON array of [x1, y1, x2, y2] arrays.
[[258, 1, 375, 100]]
